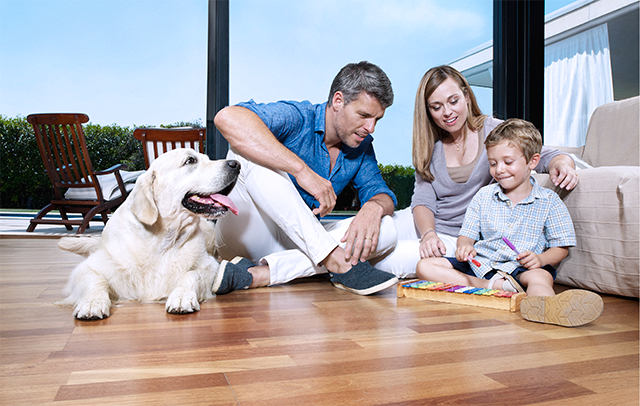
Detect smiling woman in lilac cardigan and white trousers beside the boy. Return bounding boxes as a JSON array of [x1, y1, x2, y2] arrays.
[[377, 66, 578, 277]]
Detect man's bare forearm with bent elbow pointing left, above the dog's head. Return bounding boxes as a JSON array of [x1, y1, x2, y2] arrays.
[[214, 106, 336, 216]]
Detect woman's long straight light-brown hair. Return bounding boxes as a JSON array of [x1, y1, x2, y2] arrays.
[[412, 65, 486, 182]]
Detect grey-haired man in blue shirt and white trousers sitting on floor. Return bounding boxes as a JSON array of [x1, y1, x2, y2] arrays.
[[212, 62, 398, 295]]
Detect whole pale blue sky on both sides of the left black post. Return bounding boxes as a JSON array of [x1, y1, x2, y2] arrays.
[[0, 0, 572, 165]]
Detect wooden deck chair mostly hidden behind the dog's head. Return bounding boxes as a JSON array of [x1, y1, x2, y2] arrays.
[[133, 127, 207, 169]]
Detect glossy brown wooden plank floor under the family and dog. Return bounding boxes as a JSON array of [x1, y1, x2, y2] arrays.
[[0, 238, 639, 406]]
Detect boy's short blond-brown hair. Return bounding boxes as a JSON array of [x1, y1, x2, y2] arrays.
[[484, 118, 542, 162]]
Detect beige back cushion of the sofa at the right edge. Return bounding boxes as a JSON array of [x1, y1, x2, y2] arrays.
[[582, 96, 640, 166]]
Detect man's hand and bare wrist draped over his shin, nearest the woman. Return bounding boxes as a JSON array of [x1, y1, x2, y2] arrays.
[[341, 193, 395, 265]]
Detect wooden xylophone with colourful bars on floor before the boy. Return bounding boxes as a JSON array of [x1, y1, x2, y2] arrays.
[[398, 280, 527, 312]]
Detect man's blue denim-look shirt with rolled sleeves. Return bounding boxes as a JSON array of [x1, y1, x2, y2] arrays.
[[238, 100, 398, 208]]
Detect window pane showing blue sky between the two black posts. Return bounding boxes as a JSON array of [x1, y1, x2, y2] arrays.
[[229, 0, 493, 165]]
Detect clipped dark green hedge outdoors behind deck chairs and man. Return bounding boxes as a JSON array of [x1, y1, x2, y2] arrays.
[[0, 115, 414, 211]]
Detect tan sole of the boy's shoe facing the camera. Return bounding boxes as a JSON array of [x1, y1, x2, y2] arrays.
[[520, 289, 604, 327]]
